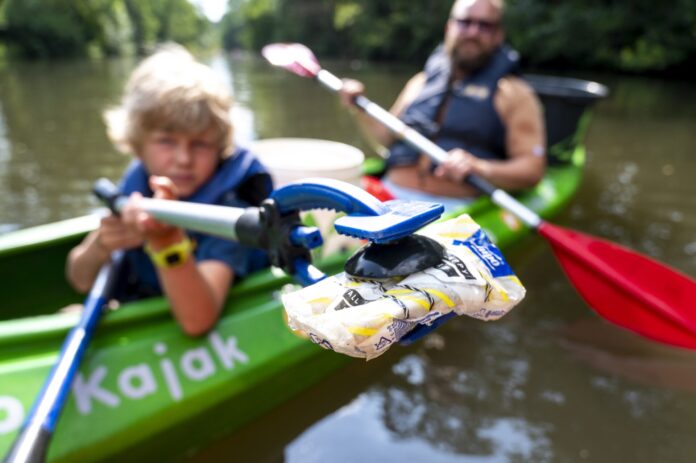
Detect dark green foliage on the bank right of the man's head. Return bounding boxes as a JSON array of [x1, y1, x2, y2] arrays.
[[506, 0, 696, 72]]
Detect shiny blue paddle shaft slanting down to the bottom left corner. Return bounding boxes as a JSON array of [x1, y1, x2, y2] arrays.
[[3, 251, 123, 463]]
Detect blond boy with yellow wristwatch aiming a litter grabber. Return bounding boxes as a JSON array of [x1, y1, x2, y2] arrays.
[[67, 45, 272, 335]]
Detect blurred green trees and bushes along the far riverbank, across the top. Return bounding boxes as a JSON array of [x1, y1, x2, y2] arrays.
[[0, 0, 696, 76]]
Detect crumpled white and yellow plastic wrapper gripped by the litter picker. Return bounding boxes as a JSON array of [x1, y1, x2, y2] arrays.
[[282, 215, 525, 360]]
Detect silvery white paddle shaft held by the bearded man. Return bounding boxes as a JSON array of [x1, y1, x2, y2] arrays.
[[316, 69, 543, 228]]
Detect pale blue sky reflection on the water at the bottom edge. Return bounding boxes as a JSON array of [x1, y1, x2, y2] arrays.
[[285, 389, 549, 463]]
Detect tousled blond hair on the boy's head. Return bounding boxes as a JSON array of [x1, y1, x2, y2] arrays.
[[104, 44, 233, 157]]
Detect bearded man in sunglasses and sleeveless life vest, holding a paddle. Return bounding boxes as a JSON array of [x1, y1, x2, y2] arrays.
[[341, 0, 546, 210]]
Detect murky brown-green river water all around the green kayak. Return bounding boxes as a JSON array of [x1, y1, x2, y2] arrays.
[[0, 52, 696, 463]]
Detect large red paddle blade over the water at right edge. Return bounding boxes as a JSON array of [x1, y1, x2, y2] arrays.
[[538, 223, 696, 349]]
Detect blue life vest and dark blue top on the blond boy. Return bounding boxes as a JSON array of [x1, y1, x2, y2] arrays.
[[116, 148, 273, 301]]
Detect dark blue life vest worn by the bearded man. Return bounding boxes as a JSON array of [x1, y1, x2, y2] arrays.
[[388, 45, 519, 167]]
